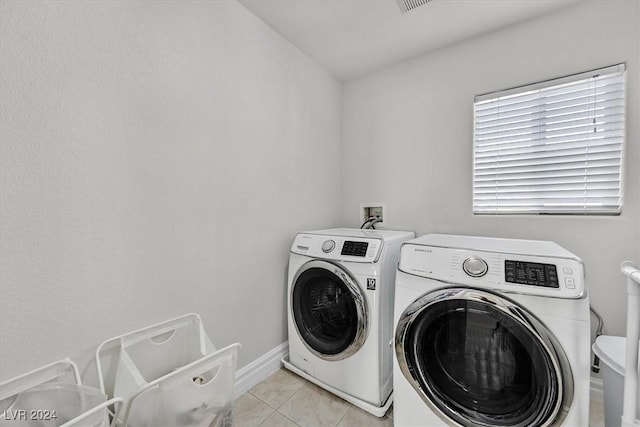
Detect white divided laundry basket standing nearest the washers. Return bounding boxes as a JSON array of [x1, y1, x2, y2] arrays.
[[96, 314, 240, 427]]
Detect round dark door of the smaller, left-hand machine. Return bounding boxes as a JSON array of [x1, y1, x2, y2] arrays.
[[291, 260, 368, 360]]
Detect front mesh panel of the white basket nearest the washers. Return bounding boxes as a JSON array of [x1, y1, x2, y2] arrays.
[[121, 344, 240, 427]]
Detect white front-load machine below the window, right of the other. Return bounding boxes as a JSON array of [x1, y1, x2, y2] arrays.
[[393, 234, 590, 427]]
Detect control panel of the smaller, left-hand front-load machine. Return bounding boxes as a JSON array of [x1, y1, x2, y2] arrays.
[[291, 233, 383, 263]]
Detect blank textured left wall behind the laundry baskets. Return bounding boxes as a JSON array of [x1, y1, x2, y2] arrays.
[[0, 0, 341, 379]]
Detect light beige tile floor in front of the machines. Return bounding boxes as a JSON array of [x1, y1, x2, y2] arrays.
[[233, 369, 604, 427]]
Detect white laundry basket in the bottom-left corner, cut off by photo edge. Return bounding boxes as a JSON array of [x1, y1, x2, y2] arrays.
[[0, 358, 122, 427]]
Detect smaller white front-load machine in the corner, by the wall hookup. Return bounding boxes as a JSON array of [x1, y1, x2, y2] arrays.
[[283, 228, 415, 416]]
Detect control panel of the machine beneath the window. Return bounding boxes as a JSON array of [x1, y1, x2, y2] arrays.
[[398, 237, 585, 298]]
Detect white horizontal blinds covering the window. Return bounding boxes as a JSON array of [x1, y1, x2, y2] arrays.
[[473, 64, 625, 214]]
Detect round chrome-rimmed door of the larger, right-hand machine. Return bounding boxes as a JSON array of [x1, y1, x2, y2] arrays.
[[395, 288, 573, 426]]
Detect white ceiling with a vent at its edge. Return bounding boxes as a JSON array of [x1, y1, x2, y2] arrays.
[[238, 0, 581, 81]]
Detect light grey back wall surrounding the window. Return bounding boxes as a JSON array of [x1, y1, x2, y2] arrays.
[[342, 1, 640, 340]]
